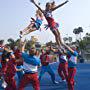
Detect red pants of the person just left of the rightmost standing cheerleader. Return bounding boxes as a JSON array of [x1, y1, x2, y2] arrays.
[[58, 62, 68, 80]]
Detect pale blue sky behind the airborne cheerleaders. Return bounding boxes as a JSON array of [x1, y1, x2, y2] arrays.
[[0, 0, 90, 43]]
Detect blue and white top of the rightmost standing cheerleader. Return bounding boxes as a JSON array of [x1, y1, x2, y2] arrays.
[[68, 51, 78, 68]]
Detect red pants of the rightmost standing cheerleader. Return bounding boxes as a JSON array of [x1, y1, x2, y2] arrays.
[[68, 68, 76, 90]]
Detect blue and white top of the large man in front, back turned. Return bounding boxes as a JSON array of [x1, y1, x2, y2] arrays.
[[22, 52, 40, 73]]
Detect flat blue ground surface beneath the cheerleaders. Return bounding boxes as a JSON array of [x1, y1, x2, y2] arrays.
[[0, 63, 90, 90]]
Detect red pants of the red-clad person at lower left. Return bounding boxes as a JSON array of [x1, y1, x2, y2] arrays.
[[5, 77, 16, 90]]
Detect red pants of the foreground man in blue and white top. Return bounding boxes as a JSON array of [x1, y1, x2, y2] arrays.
[[19, 73, 40, 90]]
